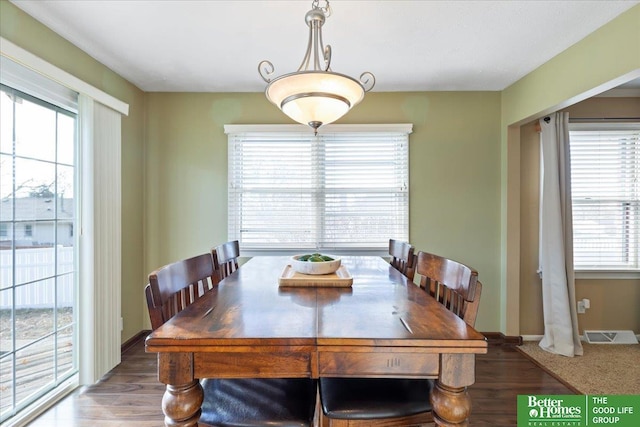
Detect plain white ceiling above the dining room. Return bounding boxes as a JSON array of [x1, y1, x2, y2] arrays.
[[12, 0, 640, 92]]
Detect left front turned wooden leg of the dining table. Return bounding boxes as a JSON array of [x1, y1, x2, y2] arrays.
[[158, 353, 204, 427]]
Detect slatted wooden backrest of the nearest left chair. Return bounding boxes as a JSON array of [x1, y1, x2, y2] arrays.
[[145, 253, 220, 329]]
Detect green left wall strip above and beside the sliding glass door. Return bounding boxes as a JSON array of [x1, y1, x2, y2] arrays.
[[0, 0, 148, 342]]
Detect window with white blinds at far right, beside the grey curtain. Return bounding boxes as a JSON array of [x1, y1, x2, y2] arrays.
[[570, 123, 640, 271]]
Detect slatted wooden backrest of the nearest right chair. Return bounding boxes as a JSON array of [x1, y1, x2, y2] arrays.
[[416, 251, 482, 326]]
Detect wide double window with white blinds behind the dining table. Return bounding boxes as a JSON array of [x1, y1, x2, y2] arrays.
[[225, 125, 411, 255]]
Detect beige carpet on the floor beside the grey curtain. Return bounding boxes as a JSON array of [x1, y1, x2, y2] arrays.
[[518, 342, 640, 395]]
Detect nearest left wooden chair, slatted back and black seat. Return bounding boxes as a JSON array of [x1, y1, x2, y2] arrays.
[[145, 253, 317, 427]]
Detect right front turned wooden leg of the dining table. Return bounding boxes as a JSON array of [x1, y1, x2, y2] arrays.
[[431, 354, 475, 427]]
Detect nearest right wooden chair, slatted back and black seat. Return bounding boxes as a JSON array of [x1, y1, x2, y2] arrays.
[[320, 252, 482, 427]]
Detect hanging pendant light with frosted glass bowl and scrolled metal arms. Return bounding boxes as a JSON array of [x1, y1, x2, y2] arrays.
[[258, 0, 375, 134]]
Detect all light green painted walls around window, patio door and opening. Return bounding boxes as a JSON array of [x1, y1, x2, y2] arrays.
[[0, 0, 640, 340]]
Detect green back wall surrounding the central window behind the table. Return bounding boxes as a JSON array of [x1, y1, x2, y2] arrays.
[[145, 92, 500, 331]]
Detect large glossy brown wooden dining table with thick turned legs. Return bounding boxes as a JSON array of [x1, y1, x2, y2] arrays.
[[145, 256, 487, 426]]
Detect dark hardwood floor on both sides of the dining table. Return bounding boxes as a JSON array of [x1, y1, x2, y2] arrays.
[[29, 341, 574, 427]]
